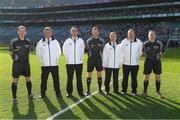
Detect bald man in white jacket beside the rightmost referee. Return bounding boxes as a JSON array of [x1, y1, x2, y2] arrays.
[[121, 29, 143, 96]]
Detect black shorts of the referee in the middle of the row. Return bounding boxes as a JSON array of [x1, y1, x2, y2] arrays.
[[87, 58, 103, 72]]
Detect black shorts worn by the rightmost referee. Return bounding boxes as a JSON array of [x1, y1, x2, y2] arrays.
[[144, 59, 162, 74]]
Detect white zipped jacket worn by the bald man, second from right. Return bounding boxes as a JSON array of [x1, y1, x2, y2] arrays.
[[120, 38, 143, 66]]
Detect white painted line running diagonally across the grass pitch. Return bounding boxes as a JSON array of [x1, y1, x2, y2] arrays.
[[47, 77, 122, 120]]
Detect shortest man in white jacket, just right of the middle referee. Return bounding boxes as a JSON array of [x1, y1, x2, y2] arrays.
[[103, 32, 121, 95]]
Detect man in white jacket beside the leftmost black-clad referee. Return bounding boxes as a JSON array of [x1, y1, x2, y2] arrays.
[[36, 27, 61, 98]]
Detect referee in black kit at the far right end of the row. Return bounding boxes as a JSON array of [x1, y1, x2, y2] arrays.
[[142, 30, 164, 97]]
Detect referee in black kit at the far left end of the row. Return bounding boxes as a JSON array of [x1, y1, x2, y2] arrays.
[[10, 26, 33, 103]]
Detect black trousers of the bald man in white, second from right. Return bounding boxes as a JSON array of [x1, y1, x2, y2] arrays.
[[122, 65, 139, 93]]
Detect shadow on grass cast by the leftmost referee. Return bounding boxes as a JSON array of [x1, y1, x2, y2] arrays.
[[12, 100, 37, 119]]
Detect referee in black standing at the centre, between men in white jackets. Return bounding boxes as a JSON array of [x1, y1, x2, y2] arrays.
[[86, 26, 104, 95]]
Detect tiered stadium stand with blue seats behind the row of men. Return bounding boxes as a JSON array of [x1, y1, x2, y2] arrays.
[[0, 0, 180, 47]]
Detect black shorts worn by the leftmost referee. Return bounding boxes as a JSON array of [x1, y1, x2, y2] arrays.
[[12, 62, 31, 78]]
